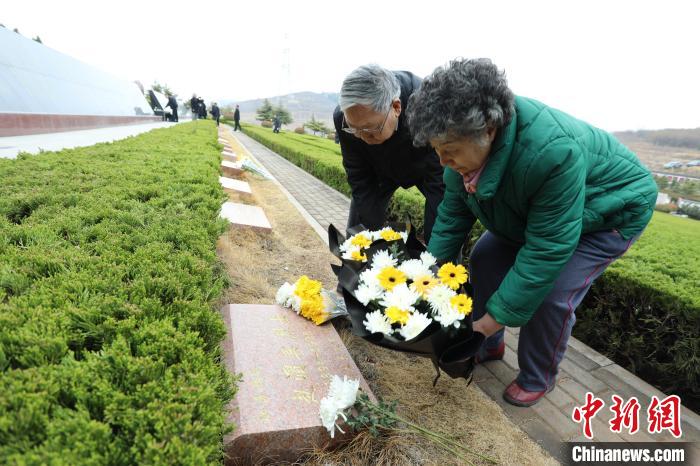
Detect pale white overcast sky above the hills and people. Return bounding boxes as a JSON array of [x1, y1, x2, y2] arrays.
[[0, 0, 700, 131]]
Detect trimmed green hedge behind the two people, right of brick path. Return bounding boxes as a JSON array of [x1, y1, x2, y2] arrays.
[[243, 125, 700, 411]]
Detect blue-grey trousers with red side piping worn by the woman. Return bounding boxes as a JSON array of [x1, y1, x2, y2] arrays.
[[469, 230, 639, 391]]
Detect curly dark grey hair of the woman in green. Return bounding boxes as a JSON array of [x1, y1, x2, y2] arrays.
[[406, 58, 515, 146]]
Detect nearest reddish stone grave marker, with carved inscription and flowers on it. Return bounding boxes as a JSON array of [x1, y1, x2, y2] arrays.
[[223, 304, 374, 464]]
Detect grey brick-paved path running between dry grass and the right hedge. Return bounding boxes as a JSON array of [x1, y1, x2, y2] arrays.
[[226, 125, 700, 462]]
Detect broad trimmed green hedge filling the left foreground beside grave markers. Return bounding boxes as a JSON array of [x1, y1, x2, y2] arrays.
[[0, 121, 235, 465]]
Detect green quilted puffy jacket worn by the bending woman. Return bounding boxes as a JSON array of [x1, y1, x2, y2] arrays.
[[428, 97, 657, 327]]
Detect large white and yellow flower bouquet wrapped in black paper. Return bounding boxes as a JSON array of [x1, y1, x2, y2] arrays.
[[328, 224, 485, 385]]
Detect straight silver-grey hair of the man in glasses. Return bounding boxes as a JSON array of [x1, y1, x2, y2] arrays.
[[340, 64, 401, 112]]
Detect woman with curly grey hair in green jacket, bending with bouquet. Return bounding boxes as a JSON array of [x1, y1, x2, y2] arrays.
[[408, 59, 657, 406]]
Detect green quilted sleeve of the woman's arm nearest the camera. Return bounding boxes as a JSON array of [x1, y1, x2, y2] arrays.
[[486, 143, 586, 327]]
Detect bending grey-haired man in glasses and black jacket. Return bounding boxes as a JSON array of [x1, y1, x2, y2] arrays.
[[333, 65, 445, 242]]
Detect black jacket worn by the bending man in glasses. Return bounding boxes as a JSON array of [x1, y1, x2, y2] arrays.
[[333, 71, 444, 198]]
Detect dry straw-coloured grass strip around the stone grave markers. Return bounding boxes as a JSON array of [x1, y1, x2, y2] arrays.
[[217, 137, 558, 465]]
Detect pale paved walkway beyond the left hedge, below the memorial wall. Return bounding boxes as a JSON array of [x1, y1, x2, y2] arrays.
[[0, 120, 178, 159]]
